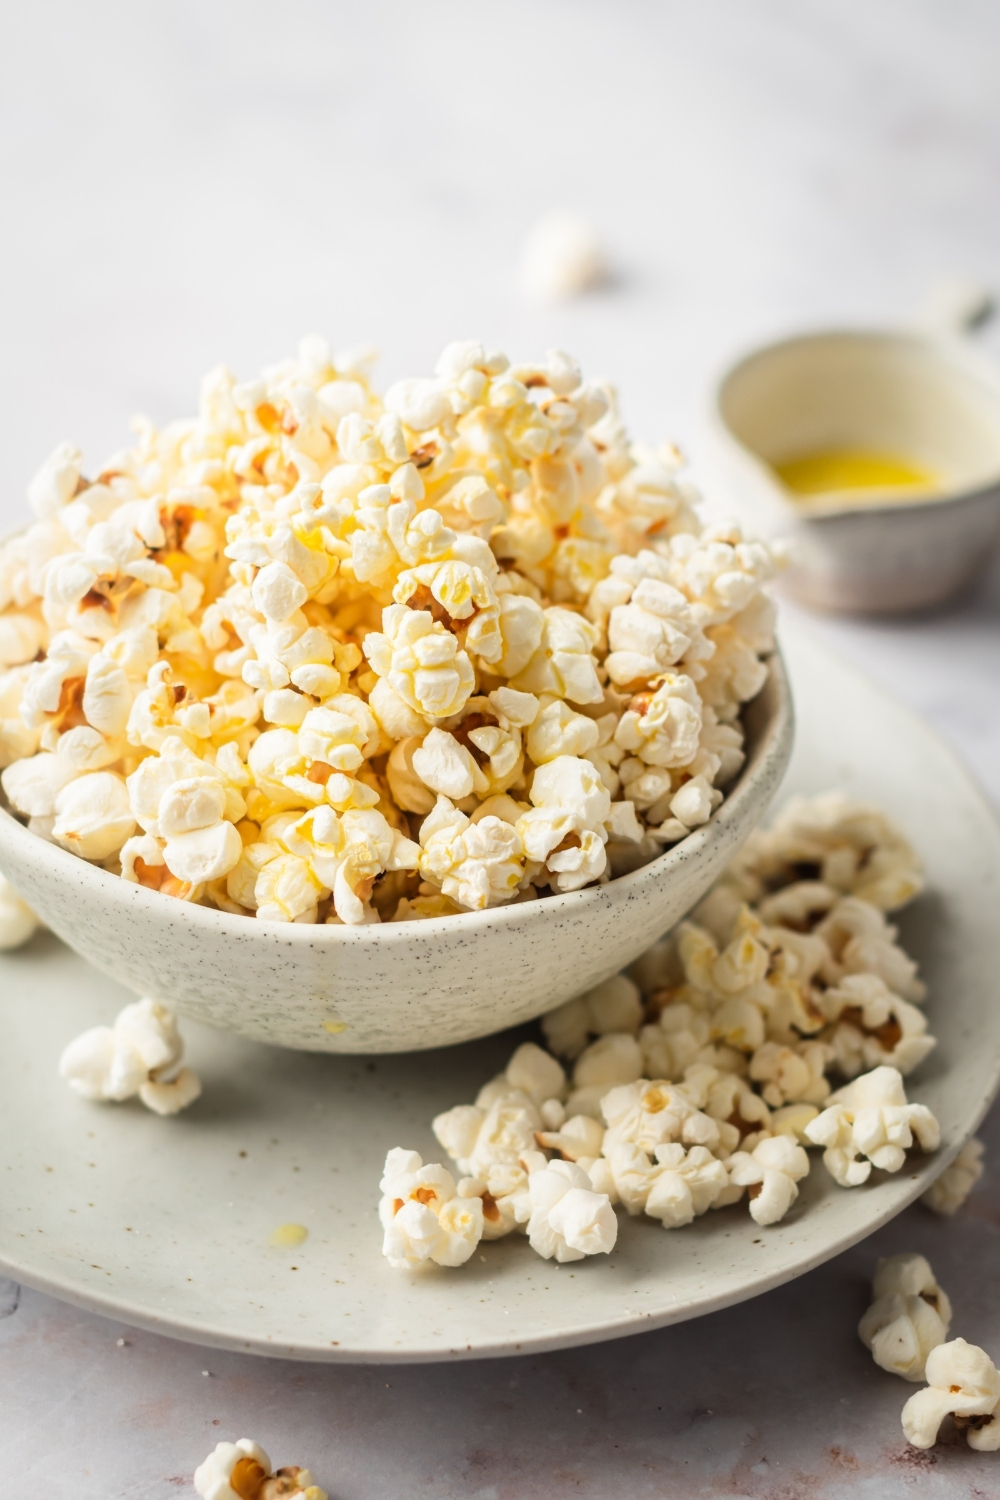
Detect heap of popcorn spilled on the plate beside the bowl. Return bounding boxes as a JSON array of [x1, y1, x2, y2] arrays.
[[379, 792, 945, 1272]]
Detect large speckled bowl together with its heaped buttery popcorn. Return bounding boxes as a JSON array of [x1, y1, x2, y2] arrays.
[[0, 338, 792, 1052]]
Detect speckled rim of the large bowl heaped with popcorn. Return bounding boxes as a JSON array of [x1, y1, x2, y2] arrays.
[[0, 645, 795, 948]]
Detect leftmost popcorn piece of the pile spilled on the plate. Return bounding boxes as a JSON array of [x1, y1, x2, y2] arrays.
[[379, 1146, 483, 1271]]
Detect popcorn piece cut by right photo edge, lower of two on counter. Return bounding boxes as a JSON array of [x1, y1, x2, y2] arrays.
[[903, 1338, 1000, 1454]]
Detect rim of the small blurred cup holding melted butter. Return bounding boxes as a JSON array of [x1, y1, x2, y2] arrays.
[[709, 324, 1000, 524]]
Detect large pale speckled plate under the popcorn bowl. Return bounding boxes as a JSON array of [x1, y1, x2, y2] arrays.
[[0, 627, 1000, 1361]]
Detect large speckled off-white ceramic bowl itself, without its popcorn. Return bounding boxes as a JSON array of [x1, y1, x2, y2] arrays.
[[0, 654, 793, 1053]]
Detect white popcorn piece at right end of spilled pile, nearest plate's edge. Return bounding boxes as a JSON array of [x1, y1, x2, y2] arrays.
[[805, 1067, 942, 1188]]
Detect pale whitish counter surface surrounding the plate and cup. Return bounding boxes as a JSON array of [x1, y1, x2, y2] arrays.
[[0, 0, 1000, 1500]]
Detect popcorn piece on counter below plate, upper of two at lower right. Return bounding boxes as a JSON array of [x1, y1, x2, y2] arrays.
[[858, 1256, 952, 1380]]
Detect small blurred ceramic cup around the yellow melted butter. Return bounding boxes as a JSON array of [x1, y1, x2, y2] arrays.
[[711, 330, 1000, 614]]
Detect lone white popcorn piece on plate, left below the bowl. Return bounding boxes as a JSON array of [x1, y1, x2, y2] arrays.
[[58, 999, 201, 1115]]
